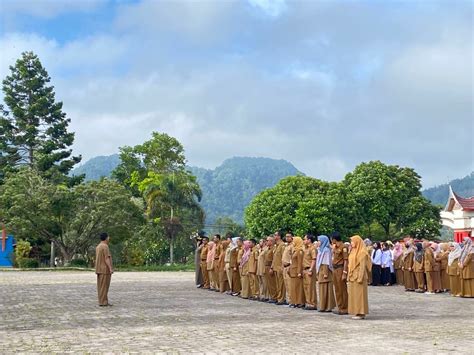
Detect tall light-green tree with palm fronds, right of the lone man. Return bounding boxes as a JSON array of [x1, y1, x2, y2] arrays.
[[113, 132, 204, 263]]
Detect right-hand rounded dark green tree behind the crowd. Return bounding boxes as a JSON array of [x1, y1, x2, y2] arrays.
[[344, 161, 421, 236]]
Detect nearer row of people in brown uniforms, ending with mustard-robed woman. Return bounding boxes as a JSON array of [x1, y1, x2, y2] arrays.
[[198, 232, 372, 319]]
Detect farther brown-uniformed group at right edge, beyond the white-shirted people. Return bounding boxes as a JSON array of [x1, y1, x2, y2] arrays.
[[394, 237, 474, 298]]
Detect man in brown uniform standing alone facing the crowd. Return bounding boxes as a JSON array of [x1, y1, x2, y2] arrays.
[[95, 233, 114, 307]]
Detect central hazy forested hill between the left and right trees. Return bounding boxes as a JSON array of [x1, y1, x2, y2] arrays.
[[190, 157, 302, 223]]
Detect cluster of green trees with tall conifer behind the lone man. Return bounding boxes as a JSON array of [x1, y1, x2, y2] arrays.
[[0, 52, 204, 265]]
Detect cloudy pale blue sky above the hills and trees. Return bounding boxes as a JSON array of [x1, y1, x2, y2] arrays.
[[0, 0, 474, 187]]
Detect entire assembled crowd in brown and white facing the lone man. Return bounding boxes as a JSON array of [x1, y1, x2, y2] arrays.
[[196, 231, 474, 319]]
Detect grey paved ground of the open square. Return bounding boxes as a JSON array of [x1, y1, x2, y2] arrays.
[[0, 271, 474, 354]]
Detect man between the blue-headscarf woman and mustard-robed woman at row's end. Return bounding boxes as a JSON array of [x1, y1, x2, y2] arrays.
[[331, 232, 349, 315]]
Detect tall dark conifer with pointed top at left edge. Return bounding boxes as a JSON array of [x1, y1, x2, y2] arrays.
[[0, 52, 82, 185]]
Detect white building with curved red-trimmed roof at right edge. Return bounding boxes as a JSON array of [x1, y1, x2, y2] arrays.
[[441, 186, 474, 243]]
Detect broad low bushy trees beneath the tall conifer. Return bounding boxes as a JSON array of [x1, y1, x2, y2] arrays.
[[0, 168, 143, 262]]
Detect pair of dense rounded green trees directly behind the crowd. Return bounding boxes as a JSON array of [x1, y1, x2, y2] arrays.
[[245, 161, 441, 240]]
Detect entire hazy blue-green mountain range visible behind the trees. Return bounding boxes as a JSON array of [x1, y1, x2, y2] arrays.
[[71, 154, 474, 224]]
